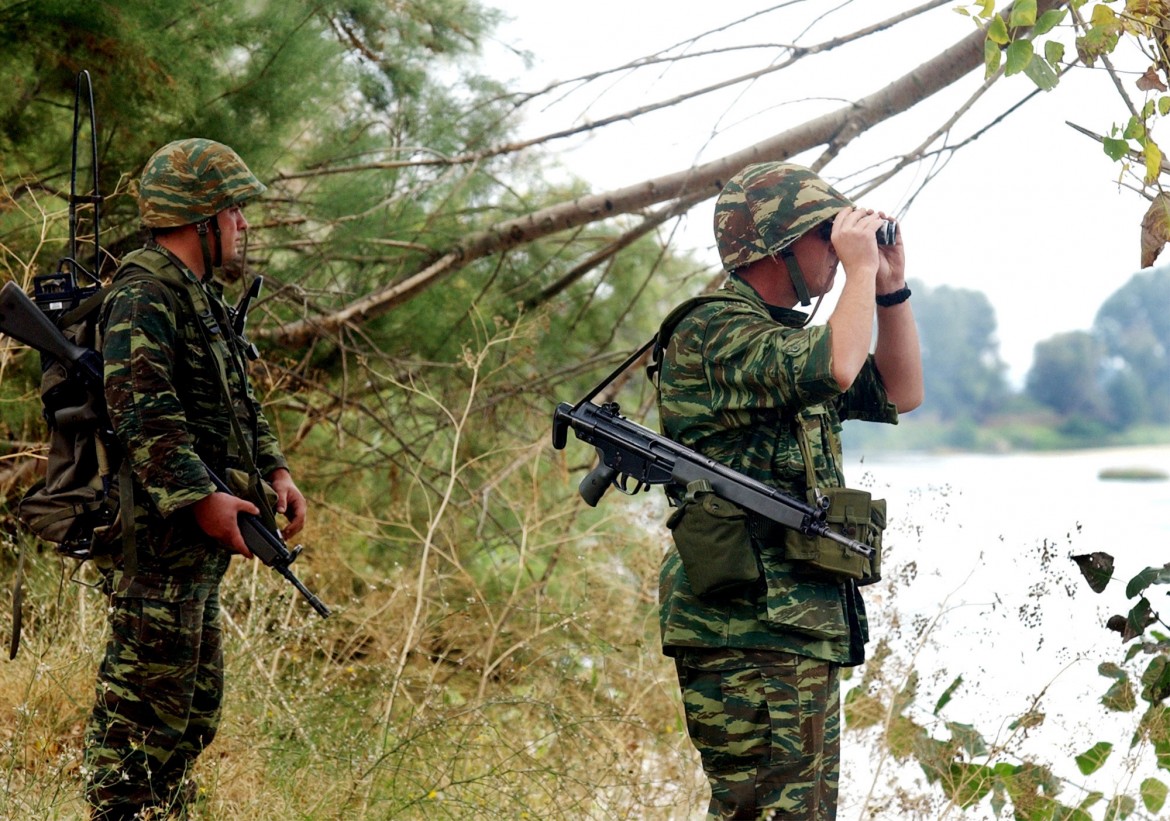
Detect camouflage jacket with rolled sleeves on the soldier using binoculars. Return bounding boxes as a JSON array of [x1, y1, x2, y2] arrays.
[[659, 275, 897, 664]]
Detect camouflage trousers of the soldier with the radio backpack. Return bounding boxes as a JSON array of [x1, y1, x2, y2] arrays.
[[83, 582, 223, 821]]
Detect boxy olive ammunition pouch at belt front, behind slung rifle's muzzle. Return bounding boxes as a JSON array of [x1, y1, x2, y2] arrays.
[[783, 488, 886, 585]]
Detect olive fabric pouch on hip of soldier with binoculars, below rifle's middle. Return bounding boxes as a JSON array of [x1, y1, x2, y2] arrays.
[[666, 480, 762, 598]]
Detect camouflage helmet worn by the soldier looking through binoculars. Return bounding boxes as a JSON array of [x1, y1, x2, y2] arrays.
[[715, 163, 853, 274]]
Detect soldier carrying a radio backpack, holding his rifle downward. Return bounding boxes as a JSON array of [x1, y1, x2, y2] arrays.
[[83, 139, 307, 821]]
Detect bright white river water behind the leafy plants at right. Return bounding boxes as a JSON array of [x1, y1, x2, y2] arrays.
[[840, 447, 1170, 819]]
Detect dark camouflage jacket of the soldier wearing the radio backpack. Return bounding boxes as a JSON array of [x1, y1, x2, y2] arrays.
[[102, 246, 287, 580]]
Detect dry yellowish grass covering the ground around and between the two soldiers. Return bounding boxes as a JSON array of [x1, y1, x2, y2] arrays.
[[0, 486, 706, 821]]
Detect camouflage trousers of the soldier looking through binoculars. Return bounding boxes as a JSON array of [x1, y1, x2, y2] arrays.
[[676, 651, 841, 821]]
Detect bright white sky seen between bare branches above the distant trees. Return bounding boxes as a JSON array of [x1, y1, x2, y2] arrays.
[[487, 0, 1151, 385]]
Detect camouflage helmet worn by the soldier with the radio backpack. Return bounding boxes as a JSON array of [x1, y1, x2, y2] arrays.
[[138, 138, 267, 228]]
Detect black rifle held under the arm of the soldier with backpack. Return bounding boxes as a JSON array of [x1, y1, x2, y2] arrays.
[[0, 281, 330, 618]]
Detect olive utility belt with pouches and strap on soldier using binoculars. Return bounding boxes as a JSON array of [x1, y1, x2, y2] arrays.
[[667, 423, 886, 598]]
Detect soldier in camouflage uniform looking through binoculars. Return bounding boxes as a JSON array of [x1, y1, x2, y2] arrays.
[[659, 163, 922, 821]]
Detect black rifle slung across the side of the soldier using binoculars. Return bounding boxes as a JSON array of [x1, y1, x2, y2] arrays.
[[552, 401, 874, 559]]
